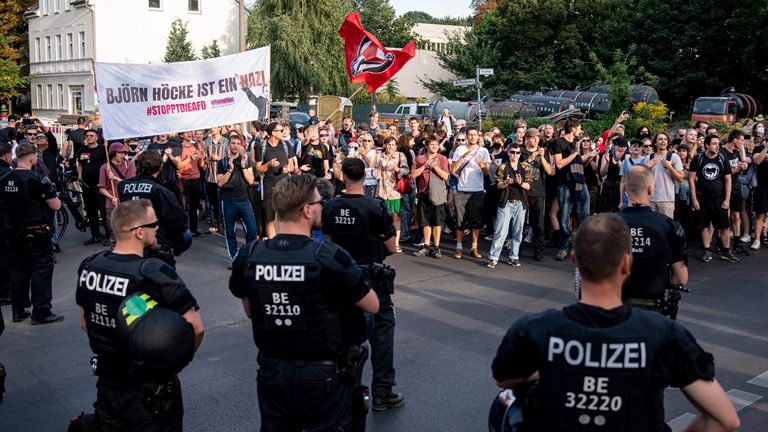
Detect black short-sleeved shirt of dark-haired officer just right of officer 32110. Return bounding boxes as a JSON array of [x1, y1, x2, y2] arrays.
[[323, 194, 394, 264]]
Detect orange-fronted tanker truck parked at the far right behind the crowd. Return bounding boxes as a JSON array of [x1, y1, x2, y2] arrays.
[[691, 88, 761, 124]]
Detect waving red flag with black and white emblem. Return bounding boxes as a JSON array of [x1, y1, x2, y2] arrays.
[[339, 12, 416, 94]]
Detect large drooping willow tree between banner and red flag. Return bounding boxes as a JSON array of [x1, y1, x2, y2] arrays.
[[246, 0, 352, 102]]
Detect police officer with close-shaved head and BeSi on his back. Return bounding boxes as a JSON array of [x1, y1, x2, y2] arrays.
[[620, 165, 688, 312]]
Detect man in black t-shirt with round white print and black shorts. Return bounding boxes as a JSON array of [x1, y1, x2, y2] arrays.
[[688, 135, 739, 262]]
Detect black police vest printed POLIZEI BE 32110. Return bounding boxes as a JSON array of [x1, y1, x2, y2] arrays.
[[244, 238, 344, 360]]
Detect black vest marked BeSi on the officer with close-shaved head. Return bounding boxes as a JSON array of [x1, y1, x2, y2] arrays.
[[619, 206, 671, 299]]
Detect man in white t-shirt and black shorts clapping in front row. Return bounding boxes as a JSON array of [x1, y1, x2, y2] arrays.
[[451, 128, 491, 259]]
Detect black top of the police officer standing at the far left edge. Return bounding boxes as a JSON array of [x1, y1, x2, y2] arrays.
[[0, 170, 53, 227]]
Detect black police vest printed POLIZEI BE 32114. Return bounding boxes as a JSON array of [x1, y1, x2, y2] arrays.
[[77, 251, 145, 365]]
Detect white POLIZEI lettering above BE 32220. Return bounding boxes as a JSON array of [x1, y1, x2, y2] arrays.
[[547, 336, 647, 369]]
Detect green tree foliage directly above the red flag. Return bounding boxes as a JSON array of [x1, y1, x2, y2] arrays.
[[354, 0, 418, 48]]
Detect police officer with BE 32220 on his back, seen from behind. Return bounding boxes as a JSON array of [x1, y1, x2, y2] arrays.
[[492, 213, 739, 432]]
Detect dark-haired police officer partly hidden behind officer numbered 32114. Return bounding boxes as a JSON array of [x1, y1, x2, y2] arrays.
[[117, 151, 192, 268]]
